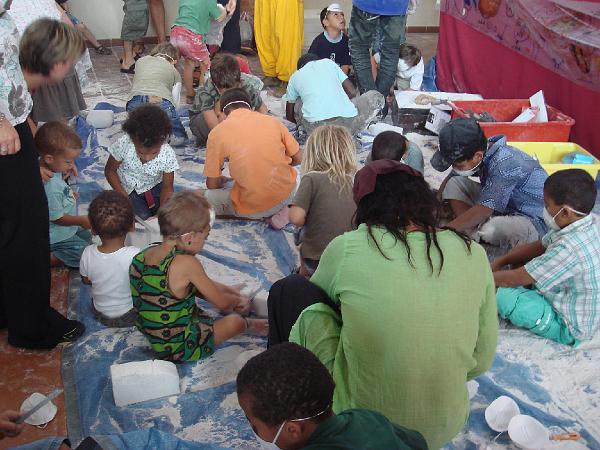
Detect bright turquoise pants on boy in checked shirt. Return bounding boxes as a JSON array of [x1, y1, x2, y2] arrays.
[[496, 287, 579, 346]]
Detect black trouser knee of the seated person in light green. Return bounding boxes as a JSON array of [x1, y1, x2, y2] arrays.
[[267, 275, 340, 347]]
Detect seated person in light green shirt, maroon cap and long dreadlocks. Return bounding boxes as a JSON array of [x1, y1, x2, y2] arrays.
[[269, 160, 498, 449]]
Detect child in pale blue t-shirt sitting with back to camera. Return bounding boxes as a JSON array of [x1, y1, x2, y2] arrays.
[[286, 53, 385, 136]]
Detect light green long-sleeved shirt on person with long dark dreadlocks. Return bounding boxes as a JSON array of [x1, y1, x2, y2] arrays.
[[290, 224, 498, 448]]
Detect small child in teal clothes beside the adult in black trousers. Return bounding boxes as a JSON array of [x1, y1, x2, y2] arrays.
[[35, 122, 92, 268]]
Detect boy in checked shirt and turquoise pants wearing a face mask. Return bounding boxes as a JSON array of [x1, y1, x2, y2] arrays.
[[492, 169, 600, 346]]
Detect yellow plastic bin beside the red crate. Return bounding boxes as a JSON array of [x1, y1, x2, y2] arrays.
[[509, 142, 600, 180]]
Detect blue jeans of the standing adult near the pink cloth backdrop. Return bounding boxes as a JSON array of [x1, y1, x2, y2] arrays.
[[350, 6, 406, 96]]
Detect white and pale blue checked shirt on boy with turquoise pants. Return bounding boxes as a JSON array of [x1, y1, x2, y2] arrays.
[[525, 214, 600, 340]]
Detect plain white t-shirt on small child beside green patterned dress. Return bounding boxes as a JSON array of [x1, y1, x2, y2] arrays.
[[79, 245, 140, 319]]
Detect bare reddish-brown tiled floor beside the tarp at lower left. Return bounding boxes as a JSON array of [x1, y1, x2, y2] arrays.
[[0, 269, 69, 449]]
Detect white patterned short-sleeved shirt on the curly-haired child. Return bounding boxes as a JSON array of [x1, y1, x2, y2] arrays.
[[108, 134, 179, 194]]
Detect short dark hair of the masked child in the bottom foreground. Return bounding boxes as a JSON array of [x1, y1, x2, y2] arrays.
[[237, 342, 335, 427]]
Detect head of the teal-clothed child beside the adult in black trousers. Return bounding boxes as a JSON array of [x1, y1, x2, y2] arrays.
[[35, 122, 82, 174]]
